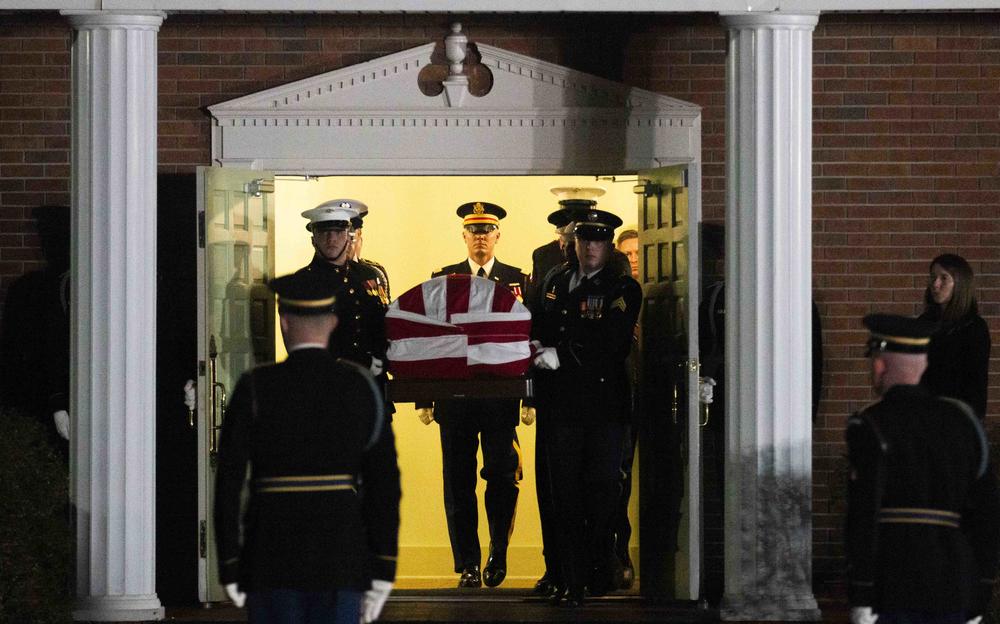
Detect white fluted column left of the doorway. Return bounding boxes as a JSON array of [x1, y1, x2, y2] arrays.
[[64, 11, 164, 622]]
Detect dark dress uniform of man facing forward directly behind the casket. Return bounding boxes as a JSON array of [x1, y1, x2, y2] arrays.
[[426, 260, 528, 572]]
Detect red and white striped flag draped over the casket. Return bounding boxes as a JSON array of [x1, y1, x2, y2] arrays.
[[385, 275, 531, 379]]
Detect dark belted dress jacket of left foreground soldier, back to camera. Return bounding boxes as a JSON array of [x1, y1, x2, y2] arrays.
[[214, 348, 400, 591]]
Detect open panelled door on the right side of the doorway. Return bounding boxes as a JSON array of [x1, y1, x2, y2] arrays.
[[634, 165, 701, 600]]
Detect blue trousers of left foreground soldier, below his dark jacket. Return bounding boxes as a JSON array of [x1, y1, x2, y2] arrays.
[[247, 589, 363, 624]]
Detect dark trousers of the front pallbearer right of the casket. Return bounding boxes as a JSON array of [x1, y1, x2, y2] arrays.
[[549, 422, 626, 593]]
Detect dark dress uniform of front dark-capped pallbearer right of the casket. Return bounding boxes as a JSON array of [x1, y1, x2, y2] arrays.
[[532, 260, 642, 601]]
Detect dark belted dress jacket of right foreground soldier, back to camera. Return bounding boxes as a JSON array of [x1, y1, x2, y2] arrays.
[[846, 385, 1000, 618]]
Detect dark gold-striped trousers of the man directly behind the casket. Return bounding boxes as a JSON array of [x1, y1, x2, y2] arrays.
[[441, 421, 521, 572]]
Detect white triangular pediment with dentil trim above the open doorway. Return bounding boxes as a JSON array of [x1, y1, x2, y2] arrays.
[[209, 43, 701, 173]]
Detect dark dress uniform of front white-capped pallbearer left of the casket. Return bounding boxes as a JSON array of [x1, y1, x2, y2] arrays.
[[299, 255, 395, 420]]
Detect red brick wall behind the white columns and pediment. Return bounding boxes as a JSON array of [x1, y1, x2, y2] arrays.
[[0, 13, 1000, 604]]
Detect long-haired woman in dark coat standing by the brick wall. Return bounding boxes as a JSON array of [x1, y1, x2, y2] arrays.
[[920, 254, 991, 419]]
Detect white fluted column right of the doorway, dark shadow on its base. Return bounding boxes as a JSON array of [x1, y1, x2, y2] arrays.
[[722, 13, 820, 620]]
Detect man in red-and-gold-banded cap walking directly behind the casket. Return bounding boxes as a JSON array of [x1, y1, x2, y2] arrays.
[[417, 202, 528, 588]]
